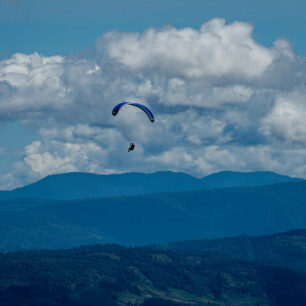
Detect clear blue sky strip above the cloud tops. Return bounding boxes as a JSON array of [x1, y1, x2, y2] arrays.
[[0, 0, 306, 56]]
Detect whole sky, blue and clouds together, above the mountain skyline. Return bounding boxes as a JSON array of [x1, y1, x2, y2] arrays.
[[0, 0, 306, 190]]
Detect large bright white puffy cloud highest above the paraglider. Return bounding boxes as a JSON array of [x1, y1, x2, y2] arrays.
[[101, 18, 273, 80]]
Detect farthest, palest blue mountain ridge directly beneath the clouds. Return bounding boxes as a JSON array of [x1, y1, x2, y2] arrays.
[[0, 171, 300, 199]]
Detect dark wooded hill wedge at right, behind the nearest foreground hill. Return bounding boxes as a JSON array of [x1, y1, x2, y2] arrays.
[[163, 229, 306, 272]]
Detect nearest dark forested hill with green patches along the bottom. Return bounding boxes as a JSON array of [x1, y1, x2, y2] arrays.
[[0, 245, 306, 306]]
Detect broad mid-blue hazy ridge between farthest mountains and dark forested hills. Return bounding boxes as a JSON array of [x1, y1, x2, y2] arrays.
[[0, 181, 306, 250]]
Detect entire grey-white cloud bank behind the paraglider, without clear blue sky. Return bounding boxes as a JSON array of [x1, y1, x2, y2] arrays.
[[0, 19, 306, 188]]
